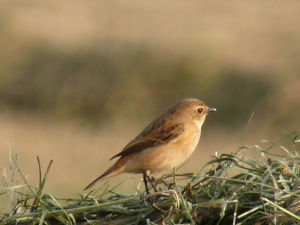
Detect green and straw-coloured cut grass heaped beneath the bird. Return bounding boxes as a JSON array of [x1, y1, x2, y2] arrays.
[[0, 130, 300, 225]]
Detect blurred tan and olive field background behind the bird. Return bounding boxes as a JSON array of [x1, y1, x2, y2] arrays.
[[0, 0, 300, 209]]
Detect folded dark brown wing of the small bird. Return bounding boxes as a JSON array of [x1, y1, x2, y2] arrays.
[[111, 120, 184, 159]]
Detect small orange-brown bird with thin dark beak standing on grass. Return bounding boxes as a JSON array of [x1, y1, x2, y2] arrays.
[[84, 98, 216, 193]]
